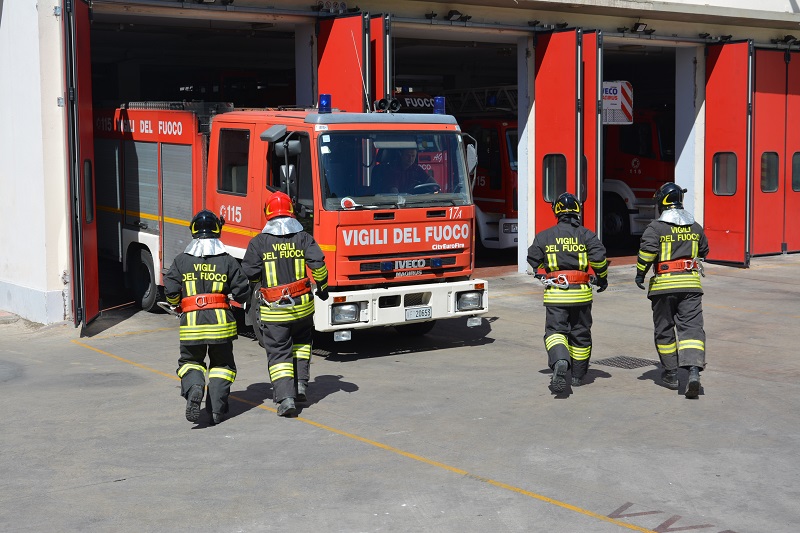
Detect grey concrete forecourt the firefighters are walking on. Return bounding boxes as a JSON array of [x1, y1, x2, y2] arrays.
[[0, 255, 800, 533]]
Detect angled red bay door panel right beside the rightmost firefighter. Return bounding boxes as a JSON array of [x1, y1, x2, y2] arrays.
[[703, 41, 753, 267]]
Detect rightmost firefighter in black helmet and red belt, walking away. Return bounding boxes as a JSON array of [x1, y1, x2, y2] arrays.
[[635, 183, 708, 398]]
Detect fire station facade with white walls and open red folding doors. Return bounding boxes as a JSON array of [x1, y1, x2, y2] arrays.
[[0, 0, 800, 325]]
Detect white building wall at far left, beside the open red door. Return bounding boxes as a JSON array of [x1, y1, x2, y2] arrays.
[[0, 0, 69, 323]]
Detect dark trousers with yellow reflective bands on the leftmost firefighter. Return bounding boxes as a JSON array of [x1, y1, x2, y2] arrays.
[[177, 341, 236, 414]]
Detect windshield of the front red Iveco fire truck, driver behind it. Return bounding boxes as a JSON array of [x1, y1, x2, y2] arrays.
[[319, 131, 472, 211]]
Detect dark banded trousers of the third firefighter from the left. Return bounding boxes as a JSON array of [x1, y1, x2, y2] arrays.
[[544, 303, 592, 379]]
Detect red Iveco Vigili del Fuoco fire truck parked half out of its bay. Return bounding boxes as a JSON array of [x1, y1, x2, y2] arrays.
[[90, 102, 488, 340]]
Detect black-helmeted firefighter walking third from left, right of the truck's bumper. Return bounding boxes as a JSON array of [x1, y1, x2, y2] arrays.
[[528, 193, 608, 393]]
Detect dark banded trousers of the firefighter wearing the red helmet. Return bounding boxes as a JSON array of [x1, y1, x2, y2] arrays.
[[261, 315, 314, 403]]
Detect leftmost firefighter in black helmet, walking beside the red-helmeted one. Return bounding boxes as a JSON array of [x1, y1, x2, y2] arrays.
[[164, 209, 250, 424]]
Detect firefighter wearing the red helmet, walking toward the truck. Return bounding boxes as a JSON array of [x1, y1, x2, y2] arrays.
[[242, 192, 328, 417]]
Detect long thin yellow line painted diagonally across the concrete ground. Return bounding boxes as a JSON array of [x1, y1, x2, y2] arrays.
[[72, 340, 656, 533]]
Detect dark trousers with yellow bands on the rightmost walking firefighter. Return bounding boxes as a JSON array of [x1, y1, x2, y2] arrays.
[[650, 293, 706, 370]]
